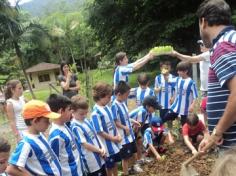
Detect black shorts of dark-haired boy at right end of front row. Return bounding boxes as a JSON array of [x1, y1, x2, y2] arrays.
[[120, 142, 137, 159]]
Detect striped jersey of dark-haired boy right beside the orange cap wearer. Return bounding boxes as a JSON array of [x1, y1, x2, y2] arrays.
[[48, 123, 83, 176]]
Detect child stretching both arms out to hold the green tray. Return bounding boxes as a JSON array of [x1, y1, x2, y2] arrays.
[[113, 52, 154, 89]]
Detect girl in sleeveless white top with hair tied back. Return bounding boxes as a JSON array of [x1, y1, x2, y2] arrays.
[[5, 80, 27, 142]]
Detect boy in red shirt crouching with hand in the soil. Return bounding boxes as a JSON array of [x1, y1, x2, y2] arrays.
[[182, 113, 208, 155]]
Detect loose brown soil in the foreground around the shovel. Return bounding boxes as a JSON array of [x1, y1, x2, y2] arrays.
[[136, 142, 216, 176]]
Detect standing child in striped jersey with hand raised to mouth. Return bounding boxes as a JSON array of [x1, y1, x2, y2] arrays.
[[155, 61, 174, 118]]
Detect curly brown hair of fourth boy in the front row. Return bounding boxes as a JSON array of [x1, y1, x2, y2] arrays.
[[93, 82, 112, 102]]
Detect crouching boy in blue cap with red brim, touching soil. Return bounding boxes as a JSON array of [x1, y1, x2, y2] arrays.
[[143, 116, 171, 160]]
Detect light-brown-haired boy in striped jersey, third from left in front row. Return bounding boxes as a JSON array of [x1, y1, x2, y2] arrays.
[[71, 96, 106, 176]]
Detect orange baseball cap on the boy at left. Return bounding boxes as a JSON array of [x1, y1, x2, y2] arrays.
[[22, 100, 61, 119]]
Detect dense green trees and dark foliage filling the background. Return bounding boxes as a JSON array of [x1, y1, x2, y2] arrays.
[[0, 0, 236, 95]]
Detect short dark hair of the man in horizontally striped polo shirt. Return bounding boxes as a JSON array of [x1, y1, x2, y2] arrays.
[[197, 0, 231, 26]]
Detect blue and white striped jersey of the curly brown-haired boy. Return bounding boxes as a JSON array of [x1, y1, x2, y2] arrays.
[[91, 104, 121, 157]]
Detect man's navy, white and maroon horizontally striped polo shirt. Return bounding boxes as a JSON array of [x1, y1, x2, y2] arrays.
[[207, 26, 236, 149]]
